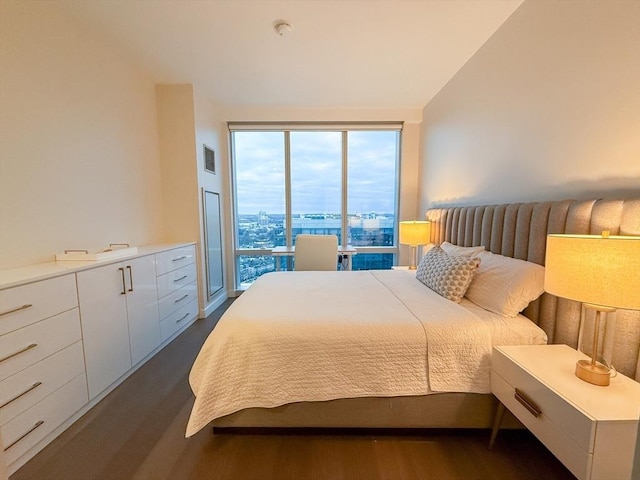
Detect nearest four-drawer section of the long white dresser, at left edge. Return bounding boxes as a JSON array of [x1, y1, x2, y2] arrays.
[[0, 274, 88, 464]]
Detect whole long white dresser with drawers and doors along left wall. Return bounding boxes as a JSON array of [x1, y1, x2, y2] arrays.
[[0, 244, 199, 474]]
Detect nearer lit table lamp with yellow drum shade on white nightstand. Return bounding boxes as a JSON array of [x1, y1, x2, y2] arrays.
[[544, 231, 640, 386]]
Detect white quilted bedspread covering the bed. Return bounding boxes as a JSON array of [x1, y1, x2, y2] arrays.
[[186, 270, 546, 436]]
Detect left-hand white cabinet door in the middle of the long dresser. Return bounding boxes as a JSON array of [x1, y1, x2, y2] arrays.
[[77, 263, 131, 398]]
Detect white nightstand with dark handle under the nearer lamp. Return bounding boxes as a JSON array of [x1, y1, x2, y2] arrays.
[[491, 345, 640, 480]]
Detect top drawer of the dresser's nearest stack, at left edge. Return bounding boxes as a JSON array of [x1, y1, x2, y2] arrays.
[[0, 275, 78, 335]]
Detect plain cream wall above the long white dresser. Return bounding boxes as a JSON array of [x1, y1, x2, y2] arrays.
[[0, 0, 163, 268]]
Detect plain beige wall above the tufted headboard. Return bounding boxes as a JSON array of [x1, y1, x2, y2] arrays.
[[420, 0, 640, 211]]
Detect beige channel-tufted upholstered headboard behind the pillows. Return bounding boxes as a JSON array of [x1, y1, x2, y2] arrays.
[[426, 198, 640, 381]]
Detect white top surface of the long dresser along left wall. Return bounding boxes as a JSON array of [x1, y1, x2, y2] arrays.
[[0, 242, 195, 290]]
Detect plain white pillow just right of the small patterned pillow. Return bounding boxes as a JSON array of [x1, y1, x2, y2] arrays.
[[465, 252, 544, 317]]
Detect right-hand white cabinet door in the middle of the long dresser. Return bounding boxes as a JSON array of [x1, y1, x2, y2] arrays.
[[124, 255, 160, 365]]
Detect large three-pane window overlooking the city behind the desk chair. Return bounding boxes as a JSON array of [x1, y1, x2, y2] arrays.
[[229, 124, 400, 289]]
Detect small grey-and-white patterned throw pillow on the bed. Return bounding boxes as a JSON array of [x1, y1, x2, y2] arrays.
[[416, 246, 480, 303]]
